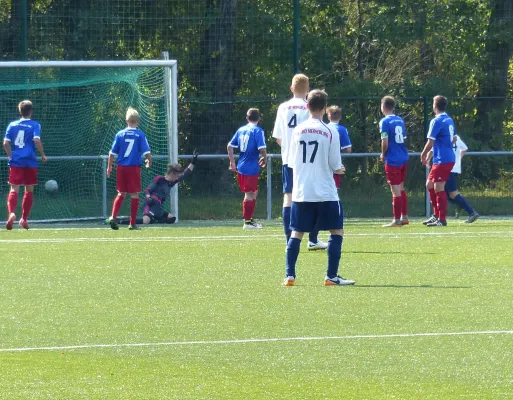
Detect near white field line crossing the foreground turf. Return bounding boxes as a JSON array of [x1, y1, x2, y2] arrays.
[[0, 330, 513, 353]]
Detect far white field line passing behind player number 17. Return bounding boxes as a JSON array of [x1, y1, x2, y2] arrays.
[[0, 231, 513, 244]]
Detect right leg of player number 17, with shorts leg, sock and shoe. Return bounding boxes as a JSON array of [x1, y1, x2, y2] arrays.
[[317, 201, 355, 286]]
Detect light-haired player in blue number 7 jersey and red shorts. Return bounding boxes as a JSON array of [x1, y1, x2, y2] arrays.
[[107, 107, 151, 230]]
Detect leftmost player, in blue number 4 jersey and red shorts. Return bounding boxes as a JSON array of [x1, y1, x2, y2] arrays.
[[4, 100, 46, 230]]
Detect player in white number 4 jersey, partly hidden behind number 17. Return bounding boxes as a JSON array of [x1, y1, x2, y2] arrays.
[[273, 74, 328, 250]]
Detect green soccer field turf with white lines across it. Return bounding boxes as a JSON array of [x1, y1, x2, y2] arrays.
[[0, 219, 513, 400]]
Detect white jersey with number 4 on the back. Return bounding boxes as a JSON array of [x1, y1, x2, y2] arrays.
[[273, 97, 310, 167]]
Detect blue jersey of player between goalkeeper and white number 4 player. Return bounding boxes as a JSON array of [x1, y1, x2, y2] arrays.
[[230, 123, 266, 176]]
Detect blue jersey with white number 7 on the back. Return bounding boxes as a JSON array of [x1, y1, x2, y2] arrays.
[[110, 128, 150, 167]]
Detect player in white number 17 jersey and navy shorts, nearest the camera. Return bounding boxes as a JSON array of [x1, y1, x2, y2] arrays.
[[283, 90, 355, 286]]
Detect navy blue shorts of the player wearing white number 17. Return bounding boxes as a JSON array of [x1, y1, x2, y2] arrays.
[[290, 201, 344, 232]]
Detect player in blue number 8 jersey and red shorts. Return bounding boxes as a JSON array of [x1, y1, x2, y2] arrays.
[[379, 96, 408, 227]]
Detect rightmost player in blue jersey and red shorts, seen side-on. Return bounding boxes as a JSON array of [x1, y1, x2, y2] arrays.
[[421, 96, 456, 226]]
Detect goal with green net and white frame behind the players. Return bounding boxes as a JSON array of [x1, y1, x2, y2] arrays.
[[0, 60, 177, 221]]
